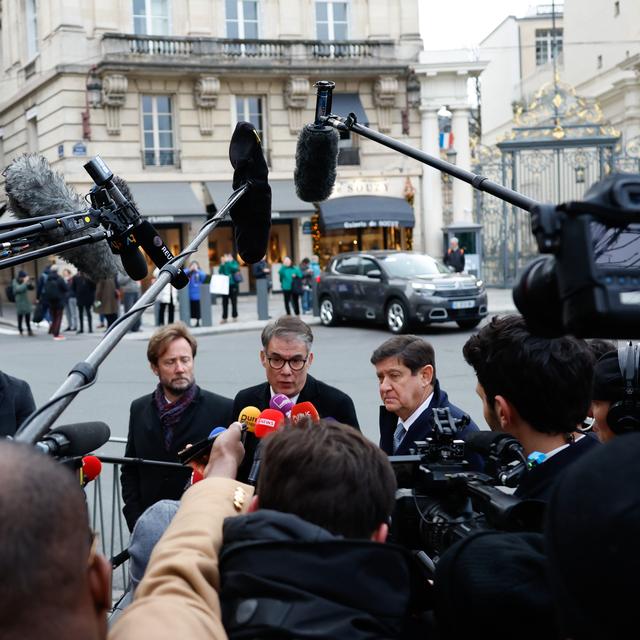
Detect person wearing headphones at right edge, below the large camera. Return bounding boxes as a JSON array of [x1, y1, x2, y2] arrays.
[[591, 344, 640, 442]]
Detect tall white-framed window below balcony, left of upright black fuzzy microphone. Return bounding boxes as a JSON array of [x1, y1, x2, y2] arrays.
[[142, 96, 177, 167]]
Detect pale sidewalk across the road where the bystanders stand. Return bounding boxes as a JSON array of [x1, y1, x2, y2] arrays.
[[0, 288, 517, 340]]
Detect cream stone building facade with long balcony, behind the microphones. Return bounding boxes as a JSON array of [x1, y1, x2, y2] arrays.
[[0, 0, 422, 292]]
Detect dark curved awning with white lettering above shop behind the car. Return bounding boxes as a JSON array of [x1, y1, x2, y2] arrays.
[[320, 196, 414, 230]]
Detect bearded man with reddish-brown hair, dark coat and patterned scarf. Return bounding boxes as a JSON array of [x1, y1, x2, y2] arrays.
[[121, 323, 232, 529]]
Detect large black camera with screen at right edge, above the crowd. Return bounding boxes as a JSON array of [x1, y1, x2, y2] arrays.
[[513, 174, 640, 338]]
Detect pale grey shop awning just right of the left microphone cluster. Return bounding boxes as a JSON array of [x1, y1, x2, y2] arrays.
[[129, 182, 205, 222]]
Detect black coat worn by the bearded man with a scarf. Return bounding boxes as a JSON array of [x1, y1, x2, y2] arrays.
[[120, 387, 232, 530]]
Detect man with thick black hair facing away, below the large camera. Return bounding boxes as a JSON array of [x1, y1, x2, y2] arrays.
[[463, 315, 598, 500]]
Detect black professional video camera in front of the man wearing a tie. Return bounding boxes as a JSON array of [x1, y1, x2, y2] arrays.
[[389, 408, 543, 558]]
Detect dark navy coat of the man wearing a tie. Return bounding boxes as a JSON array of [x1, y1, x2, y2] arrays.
[[380, 379, 484, 471]]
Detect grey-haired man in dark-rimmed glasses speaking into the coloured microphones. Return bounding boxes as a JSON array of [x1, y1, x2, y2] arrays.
[[233, 316, 360, 479]]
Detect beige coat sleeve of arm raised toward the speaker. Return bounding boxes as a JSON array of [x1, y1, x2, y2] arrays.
[[108, 478, 253, 640]]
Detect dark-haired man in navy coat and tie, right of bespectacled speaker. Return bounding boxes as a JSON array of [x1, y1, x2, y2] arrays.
[[371, 336, 481, 468]]
